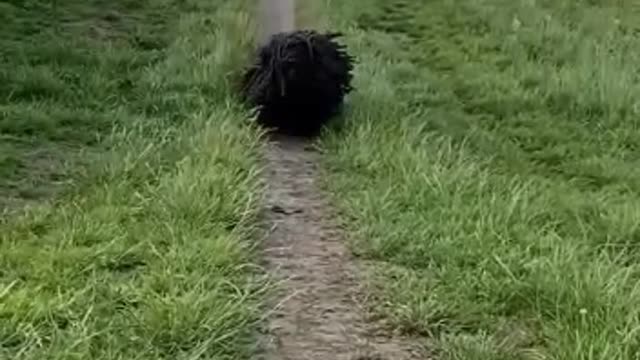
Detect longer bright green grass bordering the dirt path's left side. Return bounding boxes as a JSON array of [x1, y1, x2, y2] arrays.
[[0, 0, 264, 360]]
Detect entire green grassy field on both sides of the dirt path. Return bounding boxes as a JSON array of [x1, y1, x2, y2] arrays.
[[5, 0, 640, 360]]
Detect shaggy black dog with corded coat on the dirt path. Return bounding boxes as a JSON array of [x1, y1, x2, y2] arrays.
[[242, 30, 353, 135]]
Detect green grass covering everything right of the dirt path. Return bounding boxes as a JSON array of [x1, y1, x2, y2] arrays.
[[323, 0, 640, 360]]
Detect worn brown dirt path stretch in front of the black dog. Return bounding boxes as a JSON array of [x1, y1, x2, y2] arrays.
[[255, 137, 424, 360]]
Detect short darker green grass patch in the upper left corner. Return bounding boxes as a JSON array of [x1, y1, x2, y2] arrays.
[[0, 0, 176, 212]]
